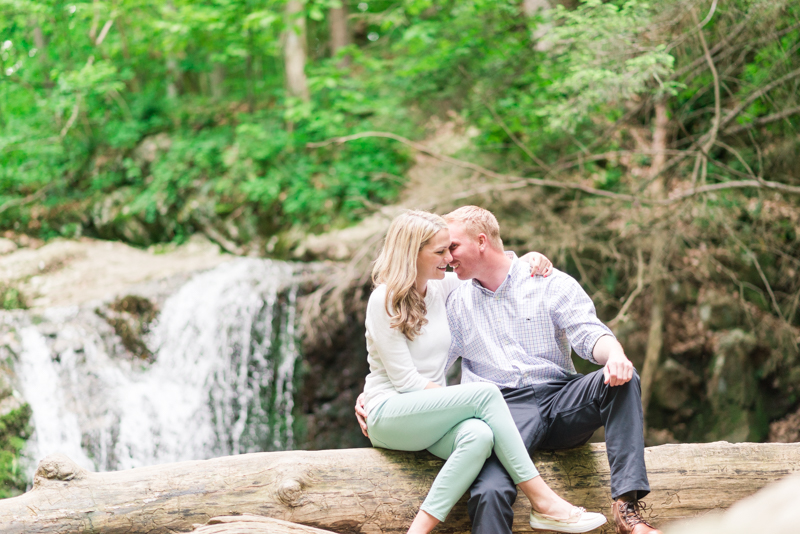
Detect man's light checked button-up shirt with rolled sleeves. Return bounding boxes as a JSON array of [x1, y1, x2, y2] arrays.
[[447, 258, 614, 388]]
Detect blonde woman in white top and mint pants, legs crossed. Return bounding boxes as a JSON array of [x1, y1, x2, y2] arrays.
[[364, 211, 605, 534]]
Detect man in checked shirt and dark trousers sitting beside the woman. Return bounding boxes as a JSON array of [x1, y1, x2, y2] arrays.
[[356, 206, 659, 534]]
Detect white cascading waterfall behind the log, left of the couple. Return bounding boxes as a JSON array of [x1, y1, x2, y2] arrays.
[[3, 259, 298, 480]]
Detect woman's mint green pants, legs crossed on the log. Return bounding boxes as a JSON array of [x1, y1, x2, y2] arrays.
[[367, 382, 539, 521]]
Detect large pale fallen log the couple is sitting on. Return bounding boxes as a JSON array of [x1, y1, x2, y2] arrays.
[[0, 442, 800, 534]]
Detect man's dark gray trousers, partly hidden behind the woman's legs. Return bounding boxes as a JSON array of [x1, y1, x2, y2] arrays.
[[469, 369, 650, 534]]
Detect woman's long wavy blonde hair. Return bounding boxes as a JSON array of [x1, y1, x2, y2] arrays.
[[372, 210, 447, 341]]
